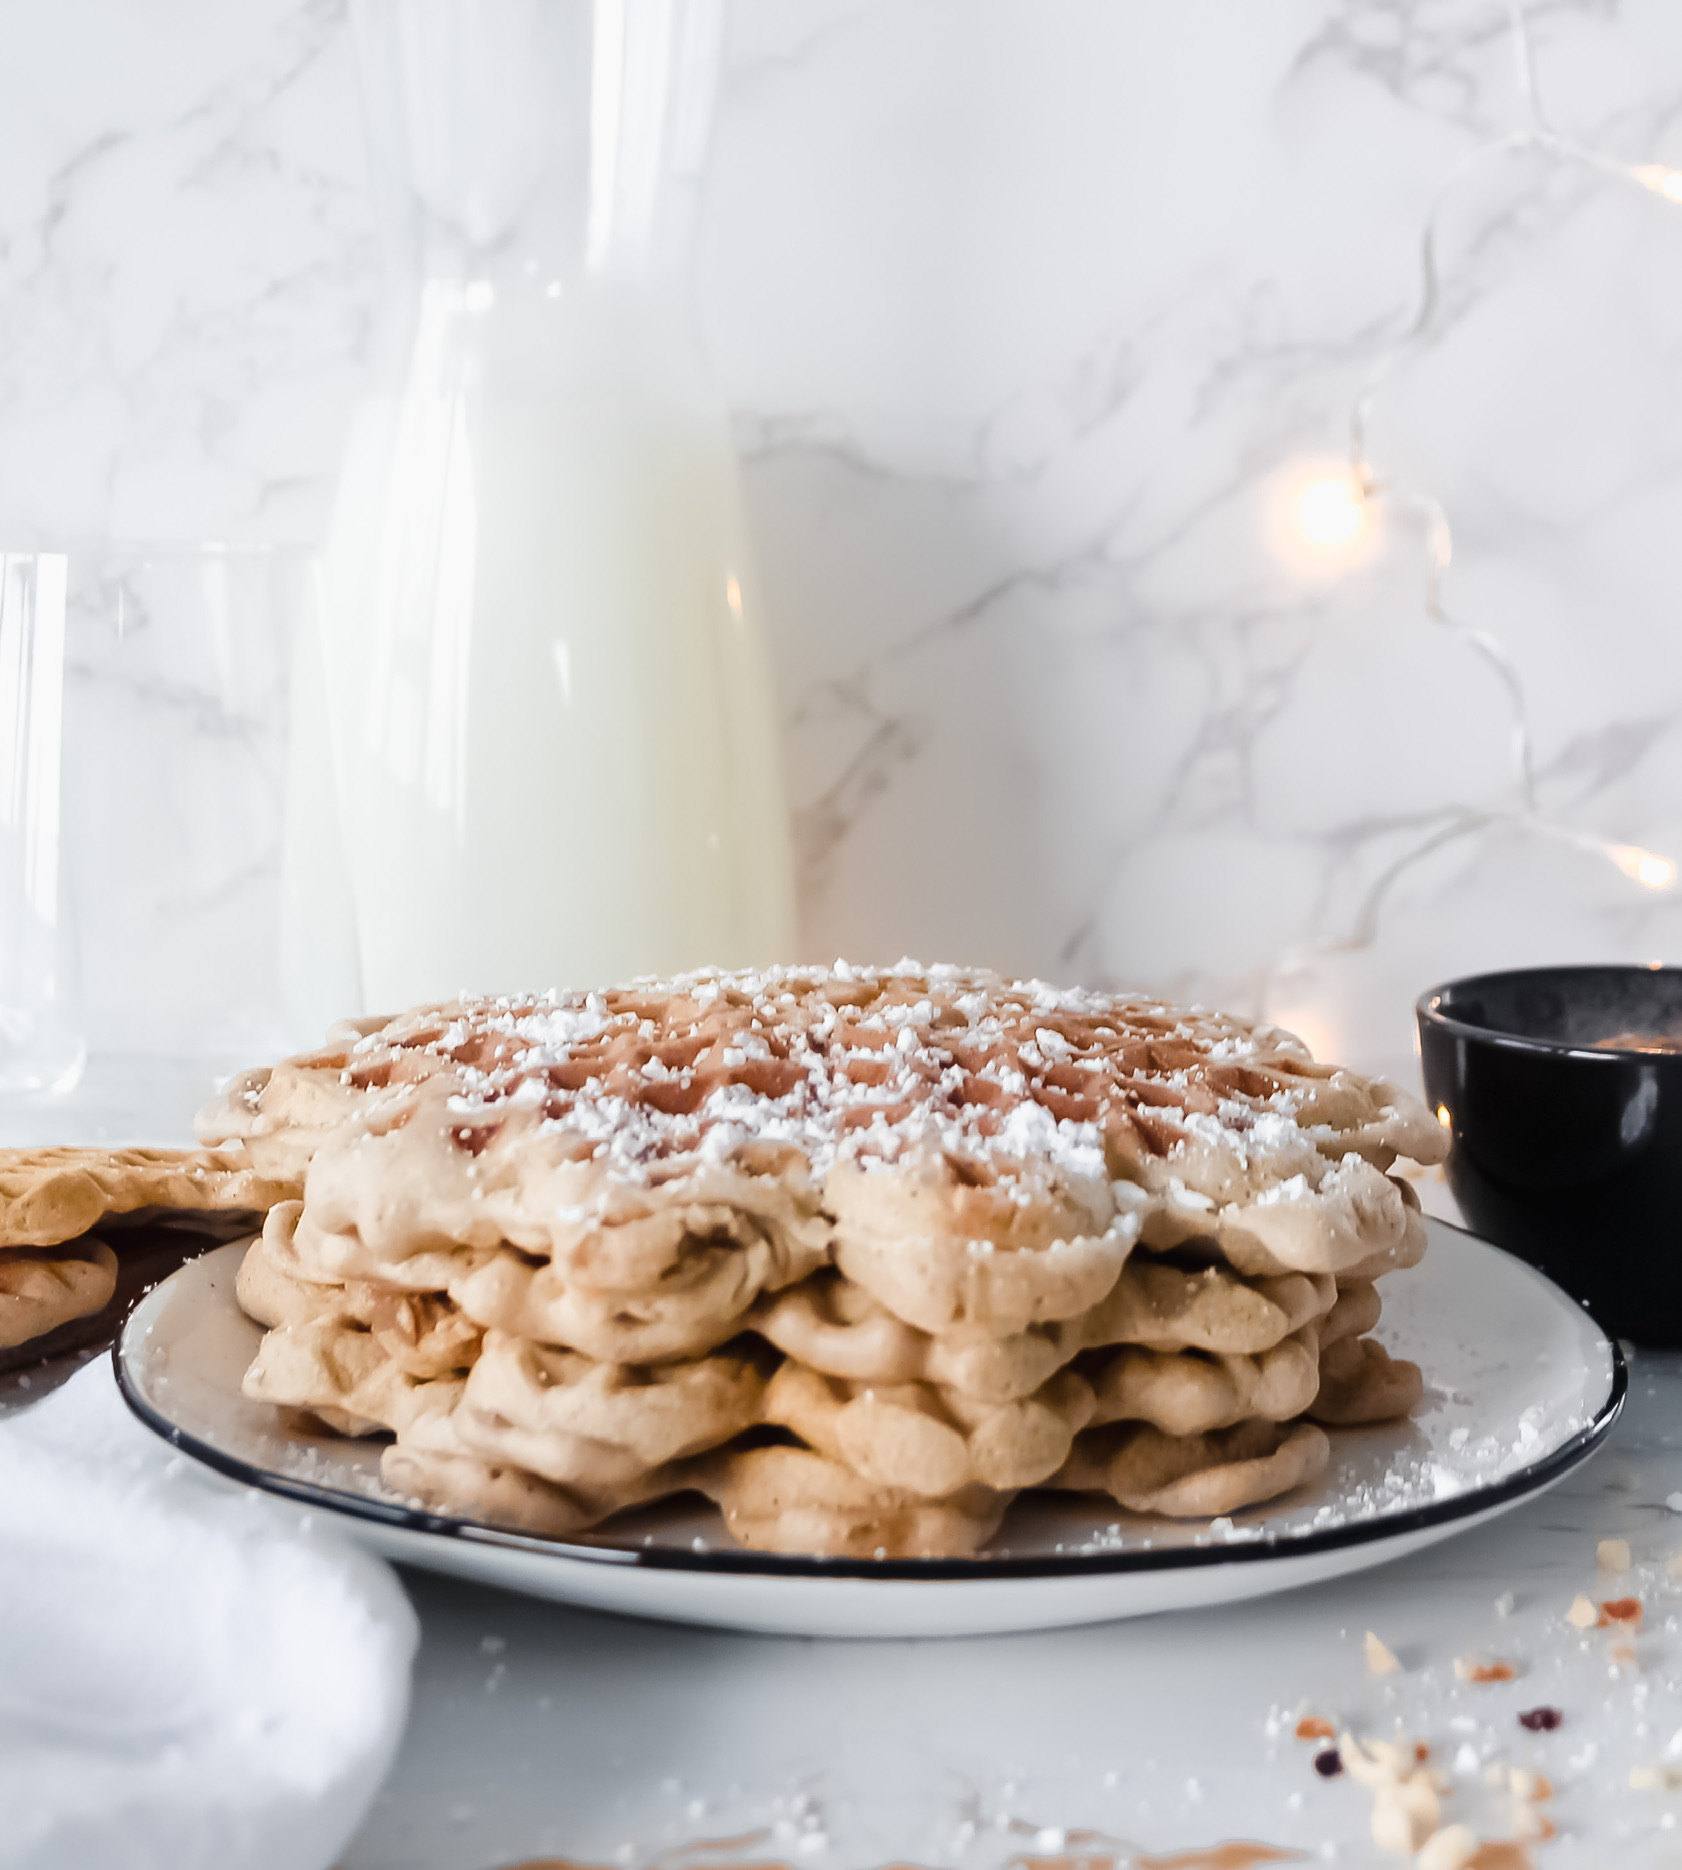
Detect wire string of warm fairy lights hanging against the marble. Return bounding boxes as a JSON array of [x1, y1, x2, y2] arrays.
[[1263, 0, 1682, 995]]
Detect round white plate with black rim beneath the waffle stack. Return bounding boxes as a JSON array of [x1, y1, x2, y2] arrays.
[[114, 1221, 1624, 1636]]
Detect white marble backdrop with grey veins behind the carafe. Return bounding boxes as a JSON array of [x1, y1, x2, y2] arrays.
[[0, 0, 1682, 1092]]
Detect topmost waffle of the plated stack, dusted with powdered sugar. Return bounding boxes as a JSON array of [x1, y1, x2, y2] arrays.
[[202, 963, 1446, 1286]]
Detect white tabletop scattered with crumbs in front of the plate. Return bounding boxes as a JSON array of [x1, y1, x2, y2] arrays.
[[344, 1356, 1682, 1870]]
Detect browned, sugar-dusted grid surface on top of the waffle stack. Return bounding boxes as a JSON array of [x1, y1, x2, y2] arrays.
[[334, 961, 1437, 1202]]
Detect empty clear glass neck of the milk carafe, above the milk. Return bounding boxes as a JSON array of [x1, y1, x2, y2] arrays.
[[354, 0, 720, 303]]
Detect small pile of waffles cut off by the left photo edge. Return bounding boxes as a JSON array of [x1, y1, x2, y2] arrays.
[[0, 1146, 290, 1369]]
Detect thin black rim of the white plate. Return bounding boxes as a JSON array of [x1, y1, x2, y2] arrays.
[[110, 1221, 1630, 1584]]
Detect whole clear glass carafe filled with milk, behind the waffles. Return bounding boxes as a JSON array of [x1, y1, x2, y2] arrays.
[[312, 0, 791, 1012]]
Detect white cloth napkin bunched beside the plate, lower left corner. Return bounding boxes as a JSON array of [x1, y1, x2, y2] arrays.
[[0, 1358, 417, 1870]]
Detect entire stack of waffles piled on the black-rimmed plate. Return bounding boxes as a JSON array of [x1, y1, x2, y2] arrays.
[[200, 963, 1446, 1556]]
